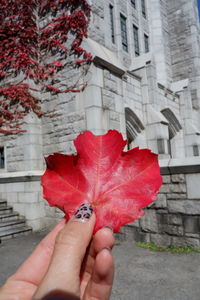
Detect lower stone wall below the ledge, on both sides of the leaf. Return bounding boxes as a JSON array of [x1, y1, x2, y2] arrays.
[[0, 158, 200, 248]]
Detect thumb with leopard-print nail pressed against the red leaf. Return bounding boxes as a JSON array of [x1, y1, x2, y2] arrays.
[[33, 204, 95, 299]]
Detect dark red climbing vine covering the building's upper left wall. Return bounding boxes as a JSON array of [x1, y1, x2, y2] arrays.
[[0, 0, 92, 134]]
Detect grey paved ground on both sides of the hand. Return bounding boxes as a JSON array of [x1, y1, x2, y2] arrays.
[[0, 233, 200, 300]]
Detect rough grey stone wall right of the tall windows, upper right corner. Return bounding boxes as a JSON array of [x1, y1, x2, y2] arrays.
[[168, 0, 200, 109]]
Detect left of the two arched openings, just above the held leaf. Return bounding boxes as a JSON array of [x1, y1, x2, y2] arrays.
[[125, 107, 145, 149]]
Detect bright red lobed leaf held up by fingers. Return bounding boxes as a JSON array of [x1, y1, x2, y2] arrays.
[[42, 130, 162, 232]]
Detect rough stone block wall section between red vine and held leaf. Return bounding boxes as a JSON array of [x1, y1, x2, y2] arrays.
[[42, 94, 83, 156]]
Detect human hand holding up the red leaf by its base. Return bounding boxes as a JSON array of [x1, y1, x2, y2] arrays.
[[0, 204, 114, 300]]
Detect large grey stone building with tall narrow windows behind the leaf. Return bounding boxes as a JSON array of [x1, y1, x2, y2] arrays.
[[0, 0, 200, 248]]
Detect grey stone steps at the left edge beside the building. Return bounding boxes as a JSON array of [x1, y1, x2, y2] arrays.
[[0, 200, 32, 242]]
